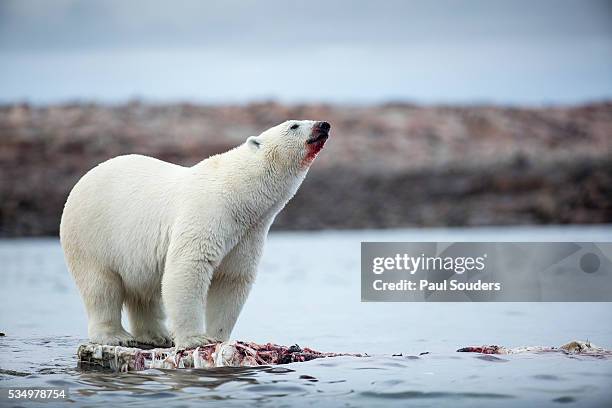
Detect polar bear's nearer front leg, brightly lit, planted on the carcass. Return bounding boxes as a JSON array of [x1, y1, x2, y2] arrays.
[[162, 244, 218, 349]]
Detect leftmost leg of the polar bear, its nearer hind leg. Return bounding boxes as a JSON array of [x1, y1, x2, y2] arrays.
[[74, 268, 135, 346]]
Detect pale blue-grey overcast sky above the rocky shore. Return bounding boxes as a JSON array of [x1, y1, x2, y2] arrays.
[[0, 0, 612, 104]]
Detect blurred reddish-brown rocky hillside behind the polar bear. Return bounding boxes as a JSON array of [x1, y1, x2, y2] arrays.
[[0, 103, 612, 236]]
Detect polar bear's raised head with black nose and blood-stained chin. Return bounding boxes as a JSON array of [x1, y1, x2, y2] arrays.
[[246, 120, 331, 169]]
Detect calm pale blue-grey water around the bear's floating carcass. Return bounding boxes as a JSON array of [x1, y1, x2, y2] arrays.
[[0, 226, 612, 407]]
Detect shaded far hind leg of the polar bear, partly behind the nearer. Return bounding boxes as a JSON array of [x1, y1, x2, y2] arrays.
[[125, 294, 172, 347]]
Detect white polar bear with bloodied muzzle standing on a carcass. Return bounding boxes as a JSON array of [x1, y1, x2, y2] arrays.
[[60, 120, 330, 348]]
